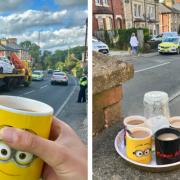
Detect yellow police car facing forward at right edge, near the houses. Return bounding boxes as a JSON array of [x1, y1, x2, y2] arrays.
[[158, 36, 180, 54]]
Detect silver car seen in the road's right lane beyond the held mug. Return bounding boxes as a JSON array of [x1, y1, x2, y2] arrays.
[[51, 71, 68, 85]]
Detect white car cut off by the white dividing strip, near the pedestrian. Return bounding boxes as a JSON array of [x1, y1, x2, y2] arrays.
[[92, 38, 109, 54]]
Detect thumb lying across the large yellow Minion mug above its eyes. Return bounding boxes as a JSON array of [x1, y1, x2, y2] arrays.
[[0, 127, 67, 167]]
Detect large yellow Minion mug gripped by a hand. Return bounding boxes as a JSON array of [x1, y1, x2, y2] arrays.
[[0, 96, 53, 180]]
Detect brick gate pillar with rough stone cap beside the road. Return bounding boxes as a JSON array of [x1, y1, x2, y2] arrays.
[[93, 52, 134, 135]]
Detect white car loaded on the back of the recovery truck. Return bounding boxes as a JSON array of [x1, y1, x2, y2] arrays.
[[0, 57, 15, 74]]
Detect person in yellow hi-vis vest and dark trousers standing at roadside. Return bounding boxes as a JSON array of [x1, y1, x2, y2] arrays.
[[77, 73, 88, 103]]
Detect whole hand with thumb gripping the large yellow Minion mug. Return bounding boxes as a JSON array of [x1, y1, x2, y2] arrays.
[[0, 117, 87, 180]]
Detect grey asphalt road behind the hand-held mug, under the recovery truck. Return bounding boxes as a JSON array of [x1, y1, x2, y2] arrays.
[[0, 76, 87, 142]]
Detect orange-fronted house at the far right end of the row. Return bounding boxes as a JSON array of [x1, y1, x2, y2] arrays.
[[160, 0, 180, 33]]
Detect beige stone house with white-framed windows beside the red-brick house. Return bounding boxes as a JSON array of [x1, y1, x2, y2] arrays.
[[123, 0, 159, 35]]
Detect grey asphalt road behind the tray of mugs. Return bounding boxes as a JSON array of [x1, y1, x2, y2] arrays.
[[122, 55, 180, 116]]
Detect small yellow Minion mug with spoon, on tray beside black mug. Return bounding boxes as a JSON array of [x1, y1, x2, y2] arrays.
[[126, 127, 153, 164]]
